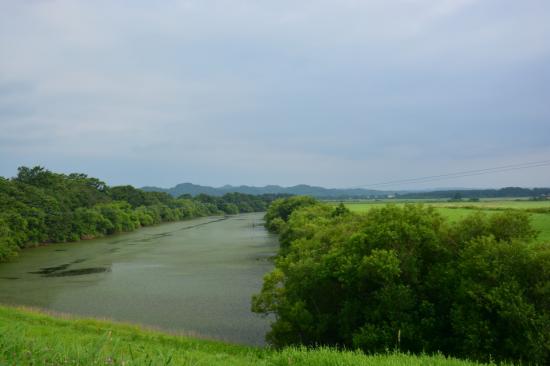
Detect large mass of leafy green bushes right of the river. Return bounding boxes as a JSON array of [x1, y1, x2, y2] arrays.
[[253, 197, 550, 364]]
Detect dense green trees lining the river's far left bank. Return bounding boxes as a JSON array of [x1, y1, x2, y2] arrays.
[[0, 167, 276, 262]]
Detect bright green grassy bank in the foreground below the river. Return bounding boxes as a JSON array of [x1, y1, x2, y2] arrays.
[[0, 306, 500, 366]]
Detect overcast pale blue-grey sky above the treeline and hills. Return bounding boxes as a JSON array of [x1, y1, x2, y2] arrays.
[[0, 0, 550, 189]]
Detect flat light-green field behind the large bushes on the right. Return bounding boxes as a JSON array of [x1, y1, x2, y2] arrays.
[[333, 200, 550, 243]]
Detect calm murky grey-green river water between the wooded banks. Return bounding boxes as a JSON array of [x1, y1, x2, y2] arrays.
[[0, 213, 277, 345]]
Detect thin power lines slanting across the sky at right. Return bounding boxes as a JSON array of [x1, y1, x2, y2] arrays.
[[353, 160, 550, 188]]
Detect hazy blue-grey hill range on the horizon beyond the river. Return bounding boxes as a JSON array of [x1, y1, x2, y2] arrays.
[[141, 183, 396, 199]]
